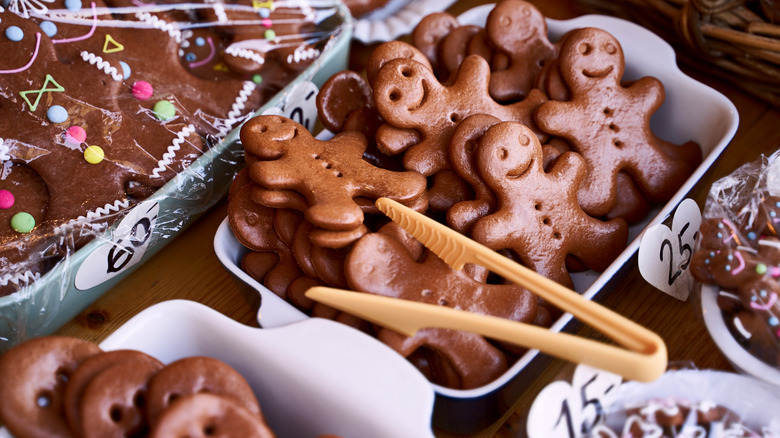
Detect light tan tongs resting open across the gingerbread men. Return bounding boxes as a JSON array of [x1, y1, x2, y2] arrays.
[[306, 198, 667, 382]]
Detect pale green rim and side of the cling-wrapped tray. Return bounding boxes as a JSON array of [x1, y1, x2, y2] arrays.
[[0, 1, 352, 354]]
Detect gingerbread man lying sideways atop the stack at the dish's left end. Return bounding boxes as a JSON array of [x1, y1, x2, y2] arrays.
[[241, 116, 426, 231]]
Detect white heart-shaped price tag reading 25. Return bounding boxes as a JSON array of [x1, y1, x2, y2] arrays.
[[638, 199, 701, 301]]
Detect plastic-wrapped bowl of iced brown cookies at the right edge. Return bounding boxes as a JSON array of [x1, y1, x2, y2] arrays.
[[690, 152, 780, 372]]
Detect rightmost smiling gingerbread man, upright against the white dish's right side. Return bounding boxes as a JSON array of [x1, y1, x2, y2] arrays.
[[535, 28, 693, 216]]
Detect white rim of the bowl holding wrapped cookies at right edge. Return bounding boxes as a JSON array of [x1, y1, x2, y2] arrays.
[[701, 285, 780, 387]]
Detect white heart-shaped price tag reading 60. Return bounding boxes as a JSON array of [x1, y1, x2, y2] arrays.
[[75, 201, 160, 290]]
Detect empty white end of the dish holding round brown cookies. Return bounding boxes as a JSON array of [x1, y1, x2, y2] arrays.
[[100, 300, 434, 438]]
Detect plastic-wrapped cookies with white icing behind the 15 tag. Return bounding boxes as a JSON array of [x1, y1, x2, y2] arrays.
[[587, 369, 780, 438]]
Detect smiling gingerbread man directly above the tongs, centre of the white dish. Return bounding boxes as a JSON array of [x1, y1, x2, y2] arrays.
[[471, 122, 628, 287]]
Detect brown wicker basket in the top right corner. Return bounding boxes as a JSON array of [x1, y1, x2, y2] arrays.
[[579, 0, 780, 106]]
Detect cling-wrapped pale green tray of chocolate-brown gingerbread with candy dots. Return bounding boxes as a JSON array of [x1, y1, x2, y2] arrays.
[[0, 0, 351, 352]]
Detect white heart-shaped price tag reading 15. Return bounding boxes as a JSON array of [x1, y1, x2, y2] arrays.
[[526, 365, 623, 438]]
